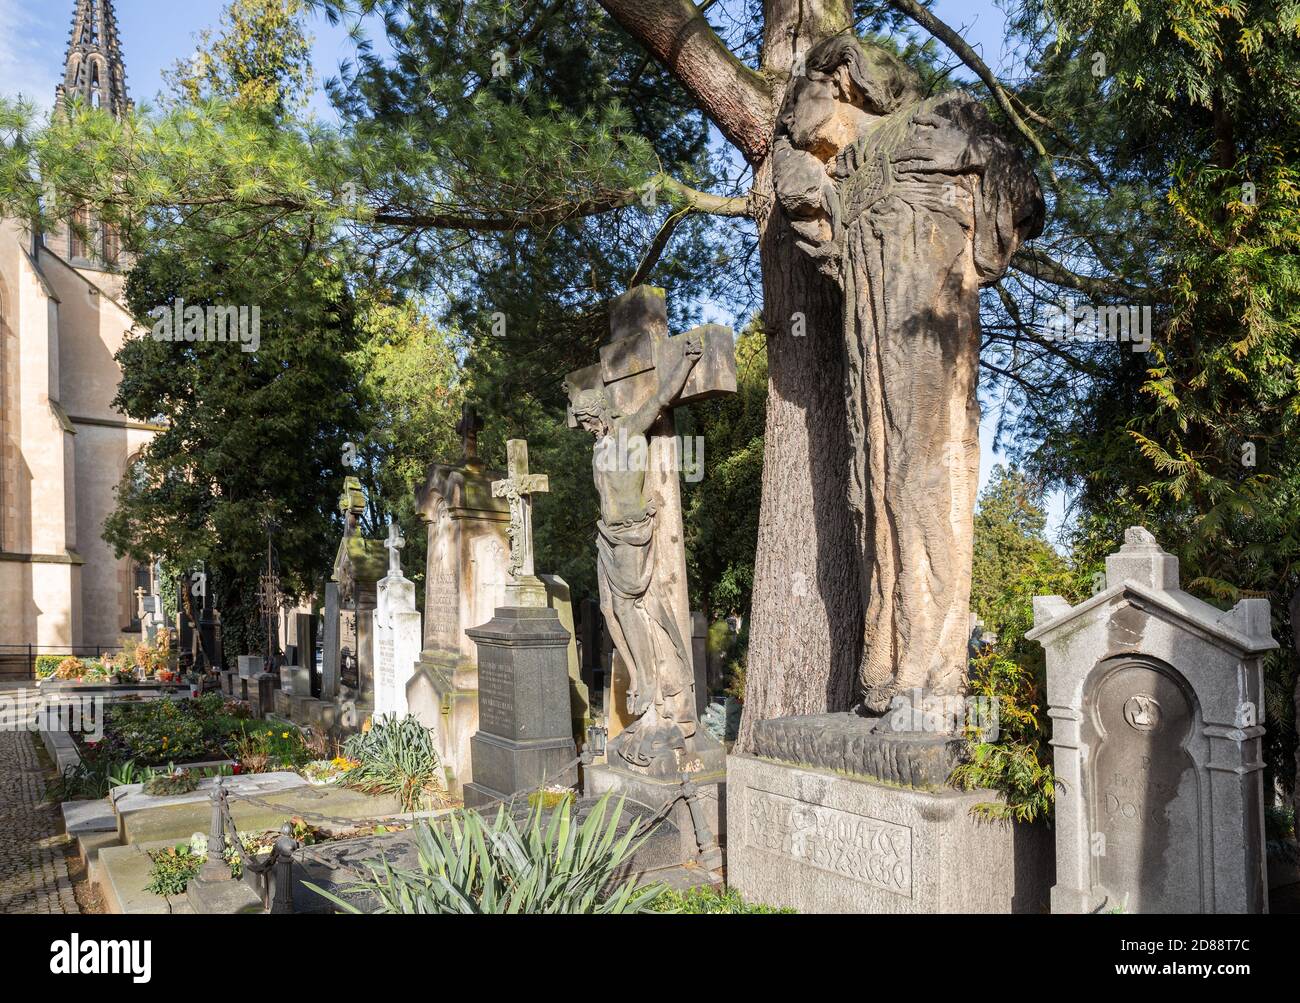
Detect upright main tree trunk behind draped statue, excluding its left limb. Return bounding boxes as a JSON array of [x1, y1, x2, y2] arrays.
[[736, 0, 862, 751]]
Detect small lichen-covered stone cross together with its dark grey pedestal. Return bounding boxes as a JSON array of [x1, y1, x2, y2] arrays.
[[464, 439, 577, 807]]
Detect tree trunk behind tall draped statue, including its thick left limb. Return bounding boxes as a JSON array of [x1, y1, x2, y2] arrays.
[[599, 0, 862, 750]]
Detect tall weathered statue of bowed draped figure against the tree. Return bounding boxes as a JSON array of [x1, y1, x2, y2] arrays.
[[774, 35, 1044, 713]]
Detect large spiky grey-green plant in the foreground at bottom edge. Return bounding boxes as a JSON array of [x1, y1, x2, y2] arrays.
[[311, 795, 664, 915]]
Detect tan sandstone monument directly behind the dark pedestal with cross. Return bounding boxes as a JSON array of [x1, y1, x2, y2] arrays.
[[407, 405, 510, 794]]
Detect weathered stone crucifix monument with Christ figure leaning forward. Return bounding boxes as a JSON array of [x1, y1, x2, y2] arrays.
[[566, 286, 736, 862]]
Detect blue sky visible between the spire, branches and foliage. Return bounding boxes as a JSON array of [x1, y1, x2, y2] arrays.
[[0, 0, 1063, 540]]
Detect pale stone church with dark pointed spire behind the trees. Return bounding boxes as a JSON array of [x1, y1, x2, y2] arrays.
[[0, 0, 157, 676]]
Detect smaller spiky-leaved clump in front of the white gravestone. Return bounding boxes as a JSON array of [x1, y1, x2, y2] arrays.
[[339, 716, 446, 811]]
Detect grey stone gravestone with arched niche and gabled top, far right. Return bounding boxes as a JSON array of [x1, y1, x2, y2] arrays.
[[1026, 527, 1278, 913]]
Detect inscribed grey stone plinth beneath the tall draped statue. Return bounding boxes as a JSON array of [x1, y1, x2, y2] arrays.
[[727, 755, 1052, 913]]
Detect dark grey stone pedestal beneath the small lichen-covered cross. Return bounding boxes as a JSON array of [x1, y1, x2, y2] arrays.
[[464, 605, 577, 808]]
